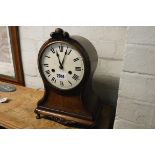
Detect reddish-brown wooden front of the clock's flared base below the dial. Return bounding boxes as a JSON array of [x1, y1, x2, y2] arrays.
[[36, 92, 95, 127]]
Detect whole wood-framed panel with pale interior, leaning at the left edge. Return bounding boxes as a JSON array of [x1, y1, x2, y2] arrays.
[[0, 26, 25, 86]]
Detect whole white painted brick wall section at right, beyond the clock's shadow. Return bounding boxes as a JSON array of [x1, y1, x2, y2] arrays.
[[114, 27, 155, 128]]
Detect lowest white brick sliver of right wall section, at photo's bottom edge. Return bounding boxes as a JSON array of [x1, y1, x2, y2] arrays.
[[114, 119, 145, 129]]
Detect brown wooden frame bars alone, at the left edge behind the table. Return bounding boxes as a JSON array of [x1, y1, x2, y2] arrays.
[[0, 26, 25, 86]]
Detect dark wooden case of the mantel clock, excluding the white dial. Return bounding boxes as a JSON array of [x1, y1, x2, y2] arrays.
[[35, 28, 102, 128]]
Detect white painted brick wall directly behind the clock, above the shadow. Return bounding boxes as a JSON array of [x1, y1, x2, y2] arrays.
[[20, 26, 126, 92]]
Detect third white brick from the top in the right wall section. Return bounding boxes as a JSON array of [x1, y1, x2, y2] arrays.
[[119, 72, 155, 104]]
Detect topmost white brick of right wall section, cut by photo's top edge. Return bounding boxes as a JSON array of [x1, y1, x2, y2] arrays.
[[127, 26, 155, 45]]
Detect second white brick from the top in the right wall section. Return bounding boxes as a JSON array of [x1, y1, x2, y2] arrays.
[[123, 44, 155, 75]]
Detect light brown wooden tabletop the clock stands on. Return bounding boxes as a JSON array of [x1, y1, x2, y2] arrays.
[[0, 82, 114, 129]]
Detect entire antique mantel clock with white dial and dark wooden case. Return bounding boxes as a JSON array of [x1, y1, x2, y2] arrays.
[[35, 28, 102, 127]]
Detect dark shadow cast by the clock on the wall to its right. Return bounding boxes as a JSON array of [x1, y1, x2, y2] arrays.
[[93, 75, 119, 129]]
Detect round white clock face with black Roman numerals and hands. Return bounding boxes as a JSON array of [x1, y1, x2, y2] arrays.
[[41, 42, 85, 90]]
